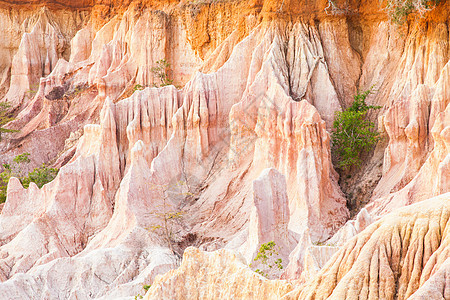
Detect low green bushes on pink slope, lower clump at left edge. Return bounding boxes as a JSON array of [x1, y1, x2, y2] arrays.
[[0, 153, 58, 203]]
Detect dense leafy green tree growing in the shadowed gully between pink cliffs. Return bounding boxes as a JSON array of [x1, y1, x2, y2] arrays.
[[331, 87, 381, 170]]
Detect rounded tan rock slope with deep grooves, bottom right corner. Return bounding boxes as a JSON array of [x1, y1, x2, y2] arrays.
[[285, 193, 450, 299]]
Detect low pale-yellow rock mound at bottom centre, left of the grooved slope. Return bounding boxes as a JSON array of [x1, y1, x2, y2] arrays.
[[144, 248, 292, 299]]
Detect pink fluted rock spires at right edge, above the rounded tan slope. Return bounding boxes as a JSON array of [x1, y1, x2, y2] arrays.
[[368, 63, 450, 214]]
